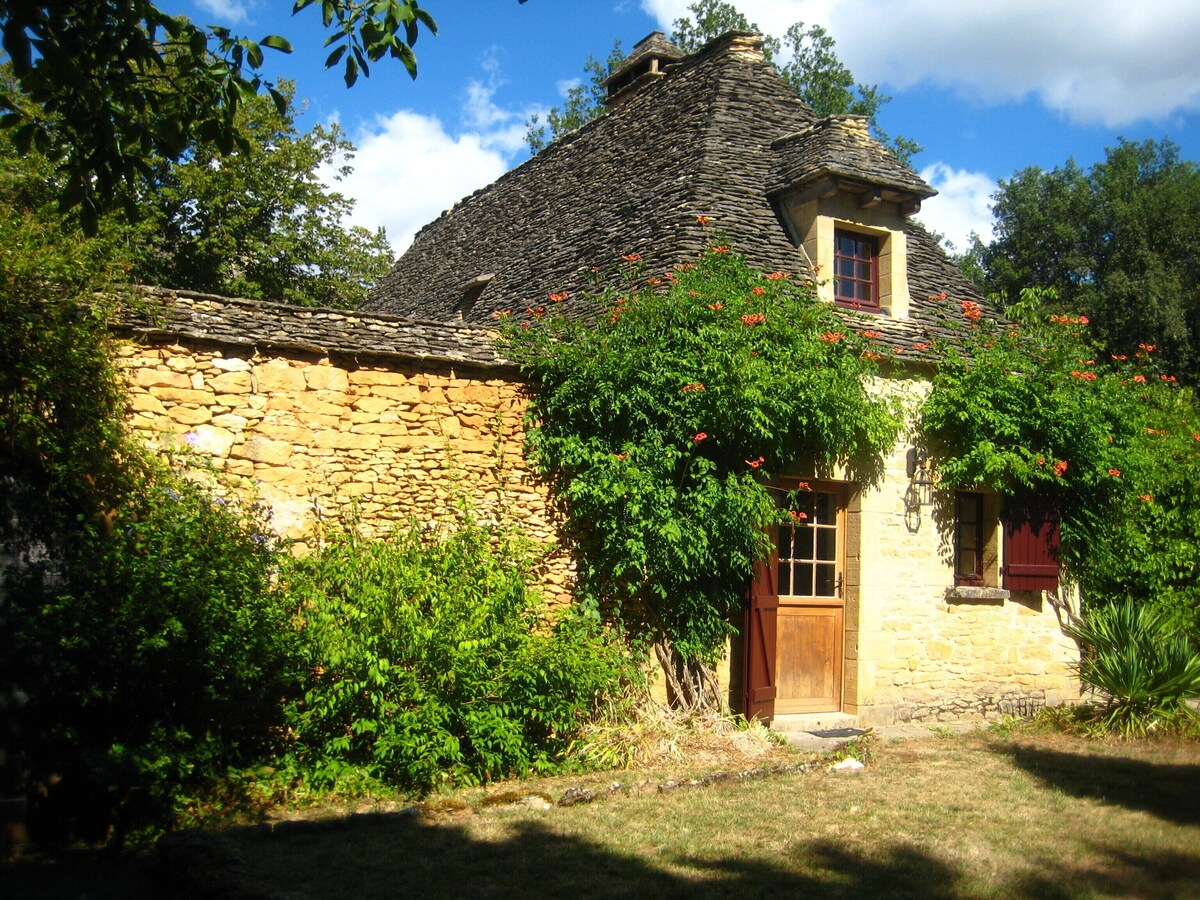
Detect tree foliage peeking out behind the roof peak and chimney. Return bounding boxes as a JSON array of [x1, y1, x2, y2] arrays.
[[526, 0, 922, 162]]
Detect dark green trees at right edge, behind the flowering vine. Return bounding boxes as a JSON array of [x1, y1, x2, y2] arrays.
[[979, 140, 1200, 383]]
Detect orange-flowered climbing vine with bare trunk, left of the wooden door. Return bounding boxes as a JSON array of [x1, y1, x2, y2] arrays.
[[502, 245, 900, 707]]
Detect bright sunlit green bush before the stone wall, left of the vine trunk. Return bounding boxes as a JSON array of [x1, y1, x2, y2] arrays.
[[286, 517, 632, 791]]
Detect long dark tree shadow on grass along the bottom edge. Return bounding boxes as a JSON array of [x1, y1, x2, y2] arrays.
[[226, 821, 962, 900]]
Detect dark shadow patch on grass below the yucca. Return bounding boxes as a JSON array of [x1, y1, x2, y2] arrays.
[[1002, 744, 1200, 826]]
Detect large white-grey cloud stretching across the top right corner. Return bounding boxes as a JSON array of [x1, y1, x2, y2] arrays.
[[642, 0, 1200, 127]]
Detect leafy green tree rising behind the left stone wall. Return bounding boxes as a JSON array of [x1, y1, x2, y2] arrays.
[[132, 82, 394, 307]]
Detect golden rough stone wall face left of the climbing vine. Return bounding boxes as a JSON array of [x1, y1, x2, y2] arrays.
[[120, 341, 571, 598]]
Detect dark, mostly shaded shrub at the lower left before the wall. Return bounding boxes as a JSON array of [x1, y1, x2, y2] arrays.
[[0, 475, 292, 839]]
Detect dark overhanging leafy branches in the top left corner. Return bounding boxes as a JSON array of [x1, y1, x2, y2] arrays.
[[0, 0, 437, 233]]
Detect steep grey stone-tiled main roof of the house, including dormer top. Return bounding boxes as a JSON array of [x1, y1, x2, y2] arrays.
[[364, 31, 986, 355]]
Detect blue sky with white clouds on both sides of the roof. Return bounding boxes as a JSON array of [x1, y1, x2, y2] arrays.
[[163, 0, 1200, 252]]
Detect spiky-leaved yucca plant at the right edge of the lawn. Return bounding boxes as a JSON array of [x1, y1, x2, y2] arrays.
[[1067, 599, 1200, 737]]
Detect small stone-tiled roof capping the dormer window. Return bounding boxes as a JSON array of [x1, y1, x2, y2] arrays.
[[768, 115, 937, 198]]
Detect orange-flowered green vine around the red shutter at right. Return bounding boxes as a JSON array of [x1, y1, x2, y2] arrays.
[[922, 293, 1200, 634]]
